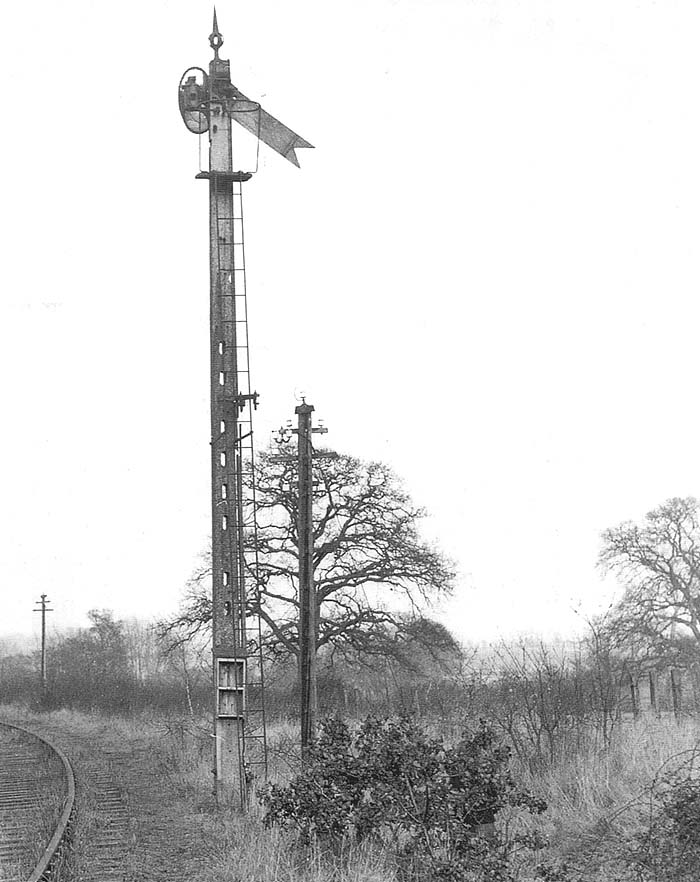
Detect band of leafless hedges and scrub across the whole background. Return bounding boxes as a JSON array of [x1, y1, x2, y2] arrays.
[[0, 610, 700, 763]]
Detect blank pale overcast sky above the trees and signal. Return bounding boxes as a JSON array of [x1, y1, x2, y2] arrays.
[[0, 0, 700, 639]]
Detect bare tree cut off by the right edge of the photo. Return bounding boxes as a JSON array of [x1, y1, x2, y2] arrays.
[[600, 497, 700, 653]]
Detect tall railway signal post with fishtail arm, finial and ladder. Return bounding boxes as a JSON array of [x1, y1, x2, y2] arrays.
[[179, 11, 312, 809]]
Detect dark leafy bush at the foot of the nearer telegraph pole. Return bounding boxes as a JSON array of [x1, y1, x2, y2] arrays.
[[261, 717, 546, 882]]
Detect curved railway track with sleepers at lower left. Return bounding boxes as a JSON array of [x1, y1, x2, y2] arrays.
[[0, 722, 75, 882]]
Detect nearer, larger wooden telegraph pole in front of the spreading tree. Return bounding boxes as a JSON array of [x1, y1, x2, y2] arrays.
[[273, 398, 332, 760]]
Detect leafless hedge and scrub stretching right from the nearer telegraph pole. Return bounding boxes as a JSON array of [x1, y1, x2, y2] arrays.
[[310, 622, 700, 766]]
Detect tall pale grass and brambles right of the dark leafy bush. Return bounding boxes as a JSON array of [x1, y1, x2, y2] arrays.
[[519, 717, 700, 882]]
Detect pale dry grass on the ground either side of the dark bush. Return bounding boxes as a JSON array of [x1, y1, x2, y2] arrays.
[[0, 709, 700, 882]]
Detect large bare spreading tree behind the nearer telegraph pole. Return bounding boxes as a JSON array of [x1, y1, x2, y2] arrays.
[[159, 446, 454, 656]]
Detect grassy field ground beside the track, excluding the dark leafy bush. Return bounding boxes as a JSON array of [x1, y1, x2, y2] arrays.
[[0, 707, 700, 882]]
